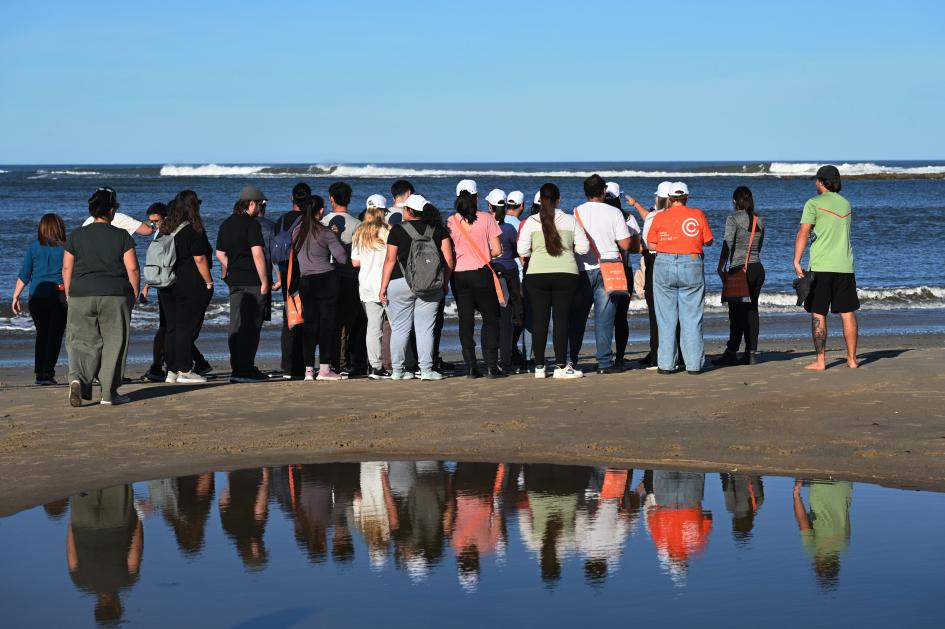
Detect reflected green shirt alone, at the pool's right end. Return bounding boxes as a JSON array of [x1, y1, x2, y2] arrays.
[[801, 481, 853, 557]]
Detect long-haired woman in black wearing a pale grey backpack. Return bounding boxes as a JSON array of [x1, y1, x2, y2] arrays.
[[160, 190, 213, 384]]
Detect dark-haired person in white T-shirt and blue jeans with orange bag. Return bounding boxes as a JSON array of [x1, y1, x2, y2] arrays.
[[568, 175, 630, 374]]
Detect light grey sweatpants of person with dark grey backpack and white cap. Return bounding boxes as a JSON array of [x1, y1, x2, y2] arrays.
[[387, 278, 443, 371]]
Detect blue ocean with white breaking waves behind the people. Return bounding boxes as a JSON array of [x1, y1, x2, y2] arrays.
[[0, 160, 945, 364]]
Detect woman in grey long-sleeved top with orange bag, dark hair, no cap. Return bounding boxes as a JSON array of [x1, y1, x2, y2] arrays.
[[712, 186, 765, 365]]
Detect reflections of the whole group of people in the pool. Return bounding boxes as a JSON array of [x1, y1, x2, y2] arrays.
[[31, 461, 916, 622]]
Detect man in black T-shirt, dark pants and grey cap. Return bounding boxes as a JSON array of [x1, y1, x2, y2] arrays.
[[216, 186, 269, 382]]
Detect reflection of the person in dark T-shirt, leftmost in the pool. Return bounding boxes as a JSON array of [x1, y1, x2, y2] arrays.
[[66, 485, 144, 623]]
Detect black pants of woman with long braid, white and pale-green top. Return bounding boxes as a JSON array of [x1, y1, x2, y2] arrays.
[[525, 273, 578, 367]]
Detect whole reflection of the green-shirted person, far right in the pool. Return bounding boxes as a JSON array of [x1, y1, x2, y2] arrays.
[[794, 480, 853, 590]]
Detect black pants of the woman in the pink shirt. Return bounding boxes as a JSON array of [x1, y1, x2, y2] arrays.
[[451, 267, 499, 368]]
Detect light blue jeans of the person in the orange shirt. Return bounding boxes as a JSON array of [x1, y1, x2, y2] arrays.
[[653, 253, 705, 371]]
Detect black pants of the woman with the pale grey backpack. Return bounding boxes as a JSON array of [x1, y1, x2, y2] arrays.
[[159, 284, 213, 372]]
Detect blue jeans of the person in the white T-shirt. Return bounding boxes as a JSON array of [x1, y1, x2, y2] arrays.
[[568, 269, 617, 369]]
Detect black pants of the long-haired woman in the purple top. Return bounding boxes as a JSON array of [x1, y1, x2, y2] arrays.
[[299, 271, 338, 367]]
